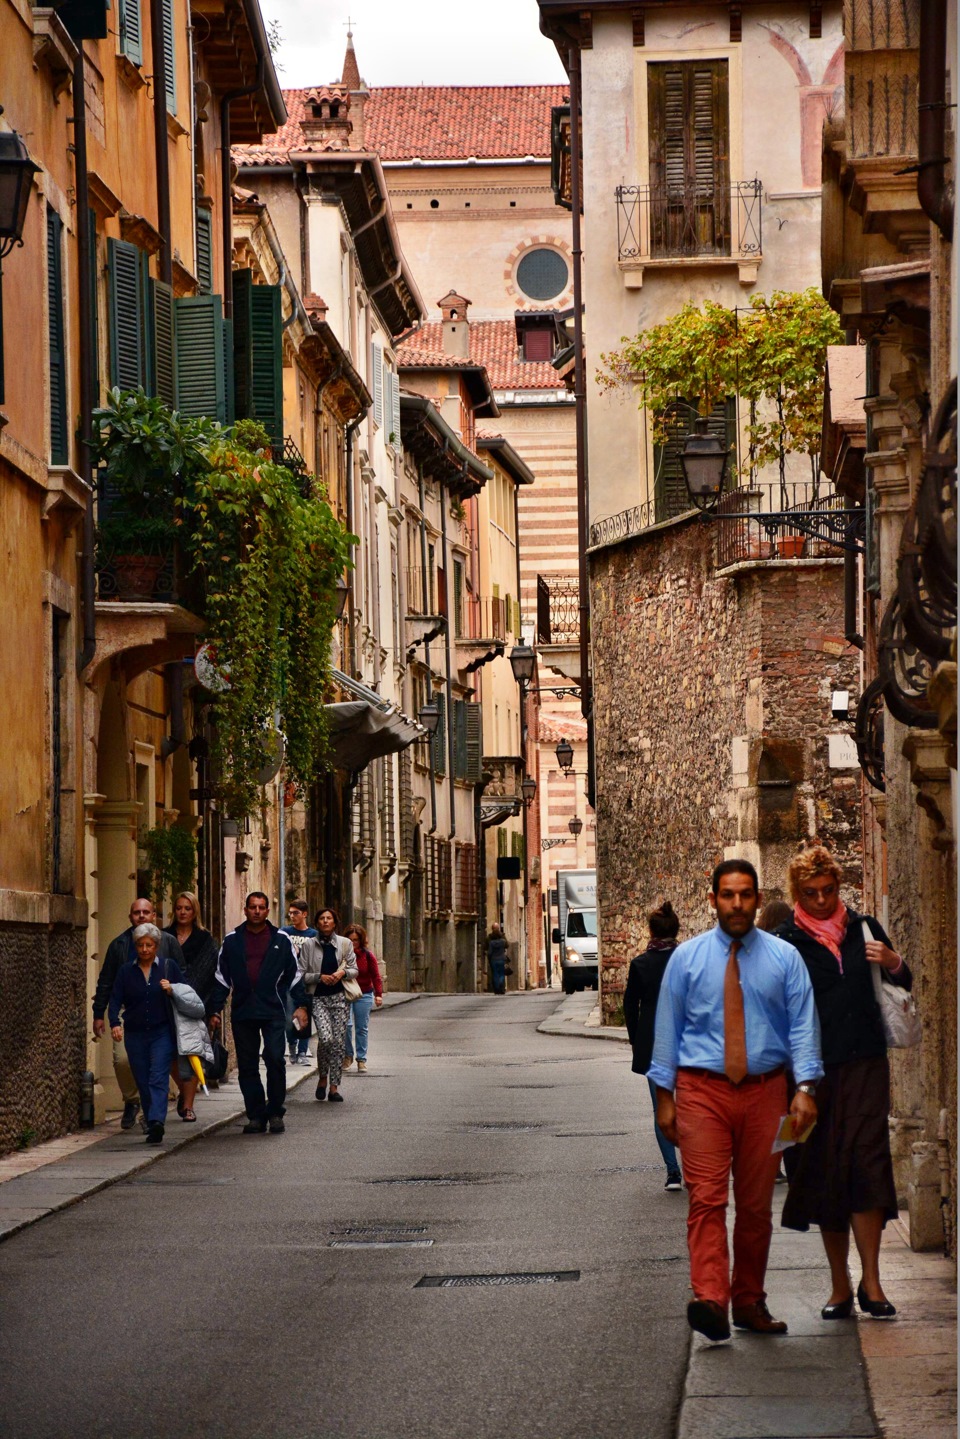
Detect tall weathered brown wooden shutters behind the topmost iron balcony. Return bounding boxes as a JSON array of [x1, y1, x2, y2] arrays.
[[646, 60, 730, 256]]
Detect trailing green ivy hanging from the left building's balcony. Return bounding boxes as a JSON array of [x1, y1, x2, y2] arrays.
[[95, 390, 357, 819]]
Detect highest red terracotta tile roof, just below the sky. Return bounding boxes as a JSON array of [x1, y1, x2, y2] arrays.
[[233, 85, 569, 164]]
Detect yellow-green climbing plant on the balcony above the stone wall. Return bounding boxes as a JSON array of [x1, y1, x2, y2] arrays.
[[597, 289, 843, 482]]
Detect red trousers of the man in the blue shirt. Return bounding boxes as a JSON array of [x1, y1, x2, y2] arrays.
[[676, 1069, 787, 1309]]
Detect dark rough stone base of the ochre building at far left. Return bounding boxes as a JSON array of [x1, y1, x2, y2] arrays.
[[0, 924, 92, 1154]]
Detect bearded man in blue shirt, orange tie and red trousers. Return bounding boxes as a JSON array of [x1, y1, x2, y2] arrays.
[[648, 859, 823, 1340]]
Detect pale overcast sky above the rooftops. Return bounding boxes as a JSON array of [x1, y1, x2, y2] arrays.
[[261, 0, 566, 89]]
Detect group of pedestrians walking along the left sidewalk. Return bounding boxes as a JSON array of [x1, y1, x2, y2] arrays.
[[94, 891, 383, 1144]]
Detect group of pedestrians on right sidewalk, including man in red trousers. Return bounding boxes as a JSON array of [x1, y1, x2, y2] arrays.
[[623, 845, 913, 1341]]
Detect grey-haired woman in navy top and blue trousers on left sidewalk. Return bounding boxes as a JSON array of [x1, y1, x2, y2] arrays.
[[109, 924, 183, 1144]]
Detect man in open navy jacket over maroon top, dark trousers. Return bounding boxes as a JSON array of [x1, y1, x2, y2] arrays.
[[210, 889, 307, 1134]]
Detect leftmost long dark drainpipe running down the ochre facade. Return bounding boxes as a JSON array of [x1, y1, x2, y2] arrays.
[[73, 40, 96, 673]]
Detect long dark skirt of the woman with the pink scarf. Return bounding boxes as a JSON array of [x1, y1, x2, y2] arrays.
[[780, 1055, 898, 1233]]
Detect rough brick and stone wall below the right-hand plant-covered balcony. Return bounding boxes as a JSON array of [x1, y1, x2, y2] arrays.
[[590, 518, 862, 1020]]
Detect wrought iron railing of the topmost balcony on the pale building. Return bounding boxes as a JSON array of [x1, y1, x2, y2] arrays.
[[616, 180, 763, 260]]
